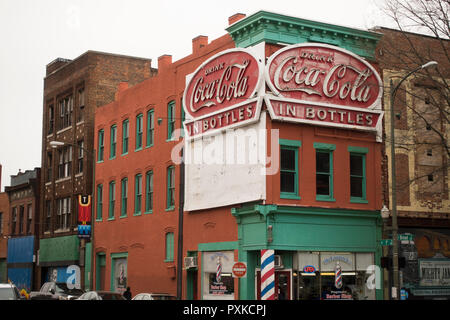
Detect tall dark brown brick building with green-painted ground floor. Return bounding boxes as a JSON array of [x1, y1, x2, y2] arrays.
[[38, 51, 154, 288]]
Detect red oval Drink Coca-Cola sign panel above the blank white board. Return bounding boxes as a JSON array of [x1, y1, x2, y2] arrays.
[[183, 49, 263, 119]]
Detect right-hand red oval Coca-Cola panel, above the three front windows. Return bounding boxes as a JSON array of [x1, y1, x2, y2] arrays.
[[265, 43, 382, 109]]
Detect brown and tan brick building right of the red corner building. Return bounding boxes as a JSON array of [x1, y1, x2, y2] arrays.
[[374, 27, 450, 299]]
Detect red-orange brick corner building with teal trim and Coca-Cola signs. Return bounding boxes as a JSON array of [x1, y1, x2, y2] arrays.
[[92, 11, 383, 299]]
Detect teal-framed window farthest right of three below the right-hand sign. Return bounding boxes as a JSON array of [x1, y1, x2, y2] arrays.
[[347, 146, 369, 203]]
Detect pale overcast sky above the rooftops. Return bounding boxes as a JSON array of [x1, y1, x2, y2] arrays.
[[0, 0, 388, 191]]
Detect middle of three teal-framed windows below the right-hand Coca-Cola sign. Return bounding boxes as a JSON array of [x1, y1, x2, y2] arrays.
[[314, 142, 336, 201]]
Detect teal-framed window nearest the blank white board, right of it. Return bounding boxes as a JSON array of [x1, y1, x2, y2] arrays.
[[280, 139, 301, 199]]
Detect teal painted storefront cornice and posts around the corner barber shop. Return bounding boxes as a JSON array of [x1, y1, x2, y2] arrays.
[[232, 205, 382, 299]]
